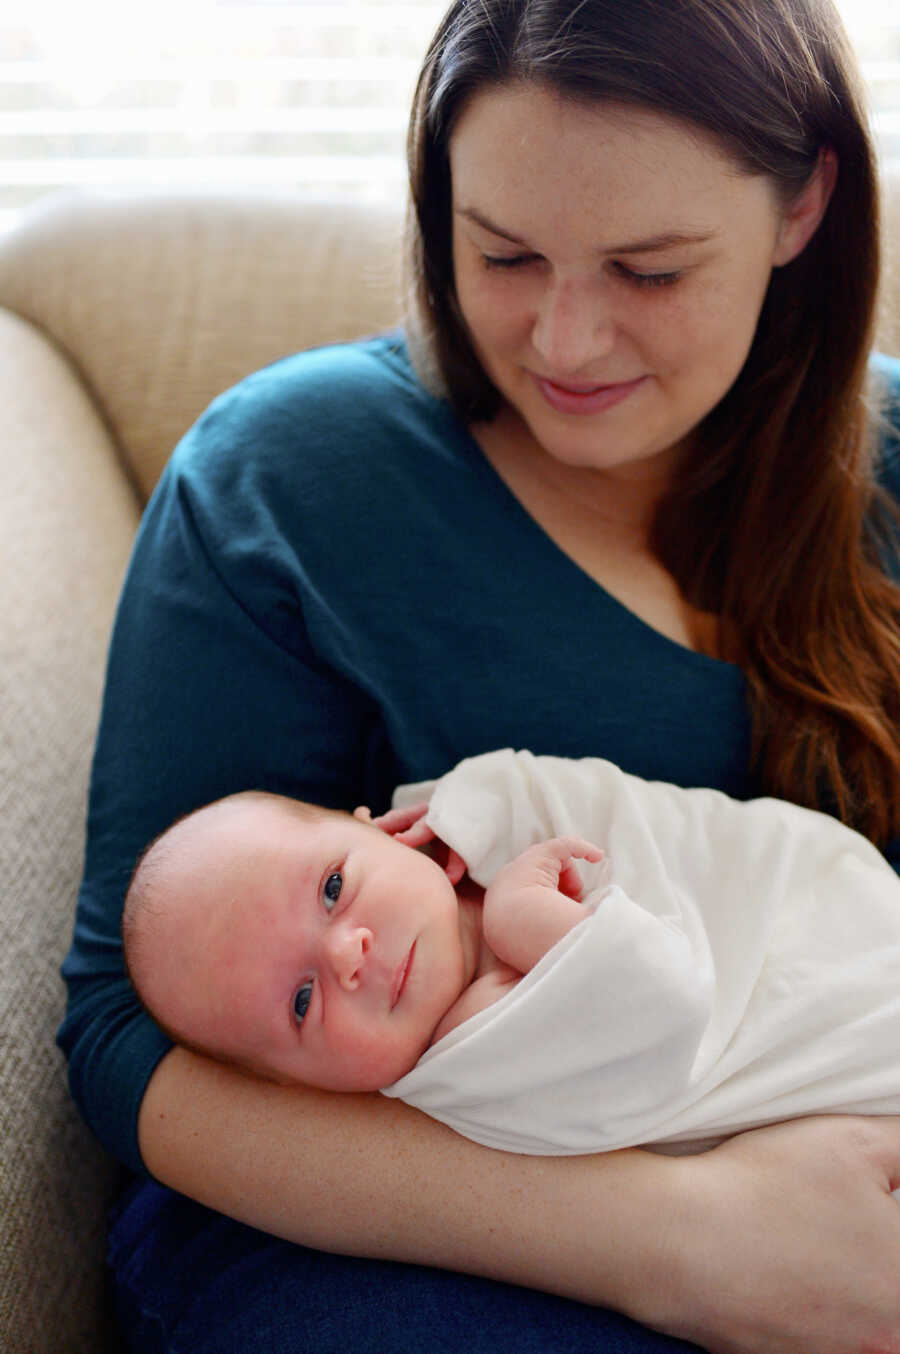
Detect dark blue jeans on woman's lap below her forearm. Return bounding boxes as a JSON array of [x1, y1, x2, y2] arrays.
[[110, 1181, 697, 1354]]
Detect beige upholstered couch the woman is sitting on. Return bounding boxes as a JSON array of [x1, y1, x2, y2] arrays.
[[0, 180, 900, 1354]]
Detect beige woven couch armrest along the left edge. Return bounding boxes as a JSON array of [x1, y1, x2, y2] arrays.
[[0, 310, 138, 1354]]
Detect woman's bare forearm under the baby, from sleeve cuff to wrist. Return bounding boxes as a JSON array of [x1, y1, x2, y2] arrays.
[[139, 1049, 673, 1309]]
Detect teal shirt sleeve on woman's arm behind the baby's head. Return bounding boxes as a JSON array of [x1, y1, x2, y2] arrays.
[[58, 362, 378, 1170]]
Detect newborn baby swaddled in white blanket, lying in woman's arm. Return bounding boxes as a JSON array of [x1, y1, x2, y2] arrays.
[[123, 749, 900, 1154]]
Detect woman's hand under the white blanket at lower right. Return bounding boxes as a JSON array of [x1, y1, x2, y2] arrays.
[[633, 1117, 900, 1354]]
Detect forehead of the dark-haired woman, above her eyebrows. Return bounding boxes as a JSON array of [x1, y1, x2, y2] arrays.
[[451, 87, 774, 252]]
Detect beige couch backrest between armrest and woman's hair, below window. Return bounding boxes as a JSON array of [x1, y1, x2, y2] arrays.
[[0, 191, 402, 498]]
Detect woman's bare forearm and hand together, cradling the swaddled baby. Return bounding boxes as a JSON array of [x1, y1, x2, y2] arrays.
[[139, 1049, 900, 1354]]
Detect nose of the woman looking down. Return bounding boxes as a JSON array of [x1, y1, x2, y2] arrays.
[[532, 279, 616, 376]]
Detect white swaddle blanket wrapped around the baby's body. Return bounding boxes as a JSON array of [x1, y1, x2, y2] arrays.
[[384, 749, 900, 1154]]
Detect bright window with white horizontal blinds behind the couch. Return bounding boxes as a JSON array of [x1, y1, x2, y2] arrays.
[[0, 0, 900, 226]]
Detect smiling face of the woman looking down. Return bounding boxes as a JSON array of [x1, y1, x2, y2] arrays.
[[451, 84, 811, 473]]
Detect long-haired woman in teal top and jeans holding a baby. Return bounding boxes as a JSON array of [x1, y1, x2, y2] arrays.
[[61, 0, 900, 1354]]
